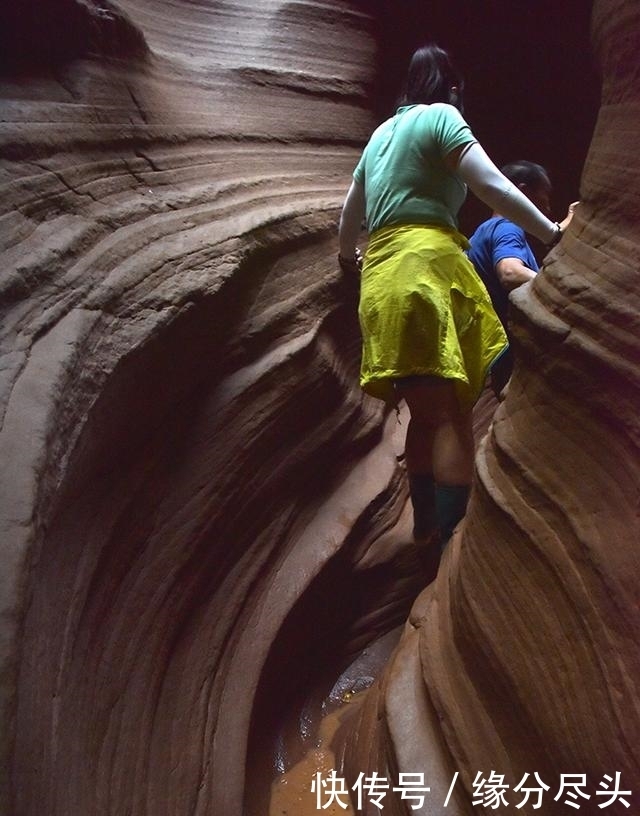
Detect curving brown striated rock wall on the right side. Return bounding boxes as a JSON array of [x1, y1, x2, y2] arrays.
[[345, 0, 640, 814]]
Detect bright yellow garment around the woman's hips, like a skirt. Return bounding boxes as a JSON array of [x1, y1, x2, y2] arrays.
[[359, 224, 508, 409]]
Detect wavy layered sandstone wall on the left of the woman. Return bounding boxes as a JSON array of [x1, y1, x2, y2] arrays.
[[0, 0, 390, 816]]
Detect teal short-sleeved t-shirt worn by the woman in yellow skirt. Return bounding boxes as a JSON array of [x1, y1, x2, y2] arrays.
[[353, 102, 476, 233]]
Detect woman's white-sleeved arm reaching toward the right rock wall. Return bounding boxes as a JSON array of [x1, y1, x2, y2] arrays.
[[447, 142, 563, 245]]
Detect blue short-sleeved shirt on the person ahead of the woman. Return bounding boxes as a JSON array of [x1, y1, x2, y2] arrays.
[[467, 220, 539, 329]]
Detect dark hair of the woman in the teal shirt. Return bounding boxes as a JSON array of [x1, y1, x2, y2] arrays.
[[404, 43, 463, 111]]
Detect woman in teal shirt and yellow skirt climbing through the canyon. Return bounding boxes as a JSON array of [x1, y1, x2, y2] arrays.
[[339, 45, 561, 546]]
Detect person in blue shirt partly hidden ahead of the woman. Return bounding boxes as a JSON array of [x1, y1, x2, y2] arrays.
[[467, 159, 577, 394]]
